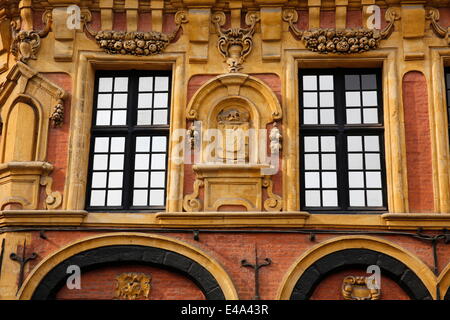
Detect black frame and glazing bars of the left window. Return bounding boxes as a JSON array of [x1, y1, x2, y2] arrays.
[[85, 69, 173, 212]]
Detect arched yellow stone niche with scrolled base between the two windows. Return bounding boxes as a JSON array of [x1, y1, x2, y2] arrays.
[[183, 73, 282, 212]]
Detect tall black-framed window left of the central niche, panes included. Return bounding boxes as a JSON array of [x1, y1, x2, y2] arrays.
[[86, 70, 171, 210]]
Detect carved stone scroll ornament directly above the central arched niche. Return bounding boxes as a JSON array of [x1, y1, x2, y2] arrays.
[[212, 11, 260, 72]]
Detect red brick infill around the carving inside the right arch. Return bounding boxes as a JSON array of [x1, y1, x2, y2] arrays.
[[310, 269, 410, 300]]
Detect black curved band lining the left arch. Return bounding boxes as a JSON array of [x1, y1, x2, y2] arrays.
[[32, 245, 225, 300]]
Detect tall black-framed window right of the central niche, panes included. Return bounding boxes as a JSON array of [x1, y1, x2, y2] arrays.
[[299, 69, 387, 212]]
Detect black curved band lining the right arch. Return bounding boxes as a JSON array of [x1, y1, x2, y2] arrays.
[[290, 249, 432, 300]]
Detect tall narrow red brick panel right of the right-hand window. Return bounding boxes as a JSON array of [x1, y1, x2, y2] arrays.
[[403, 71, 434, 212]]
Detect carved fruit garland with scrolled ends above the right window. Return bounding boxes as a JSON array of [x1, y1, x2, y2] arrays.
[[283, 8, 399, 54]]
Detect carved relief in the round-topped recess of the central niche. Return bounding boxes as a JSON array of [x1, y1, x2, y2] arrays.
[[217, 107, 250, 163]]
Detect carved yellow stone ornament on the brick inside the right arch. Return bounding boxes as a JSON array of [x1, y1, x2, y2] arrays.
[[342, 276, 381, 300]]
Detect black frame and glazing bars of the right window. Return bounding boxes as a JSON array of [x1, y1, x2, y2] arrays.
[[298, 68, 388, 214]]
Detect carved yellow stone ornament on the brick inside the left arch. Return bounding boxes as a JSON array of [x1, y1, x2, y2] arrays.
[[115, 272, 152, 300]]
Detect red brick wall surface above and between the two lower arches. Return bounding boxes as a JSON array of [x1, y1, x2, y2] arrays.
[[28, 231, 450, 299]]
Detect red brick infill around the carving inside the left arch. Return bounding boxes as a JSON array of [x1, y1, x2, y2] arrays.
[[56, 265, 205, 300]]
